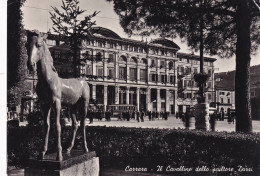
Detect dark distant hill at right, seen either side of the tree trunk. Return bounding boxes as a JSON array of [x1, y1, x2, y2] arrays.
[[215, 65, 260, 90]]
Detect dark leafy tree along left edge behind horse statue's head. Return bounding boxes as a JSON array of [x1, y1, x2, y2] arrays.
[[7, 0, 27, 107]]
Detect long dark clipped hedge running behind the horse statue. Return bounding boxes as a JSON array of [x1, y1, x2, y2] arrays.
[[7, 126, 260, 176]]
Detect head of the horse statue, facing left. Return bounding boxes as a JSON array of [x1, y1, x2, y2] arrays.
[[27, 30, 47, 71]]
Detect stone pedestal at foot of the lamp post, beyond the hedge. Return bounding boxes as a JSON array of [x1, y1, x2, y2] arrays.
[[195, 103, 209, 130]]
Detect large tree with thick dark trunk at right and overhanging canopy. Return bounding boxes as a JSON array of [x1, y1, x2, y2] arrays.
[[108, 0, 260, 132]]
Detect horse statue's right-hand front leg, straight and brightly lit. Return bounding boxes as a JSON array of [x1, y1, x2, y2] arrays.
[[54, 98, 63, 161]]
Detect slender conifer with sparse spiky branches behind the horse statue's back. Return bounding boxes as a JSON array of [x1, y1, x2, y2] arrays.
[[50, 0, 99, 77]]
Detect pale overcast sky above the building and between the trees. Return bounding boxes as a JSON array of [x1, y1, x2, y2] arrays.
[[22, 0, 260, 72]]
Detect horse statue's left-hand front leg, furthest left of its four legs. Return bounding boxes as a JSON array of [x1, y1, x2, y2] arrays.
[[39, 104, 51, 159]]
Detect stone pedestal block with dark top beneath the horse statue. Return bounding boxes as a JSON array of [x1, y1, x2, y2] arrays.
[[25, 150, 99, 176]]
